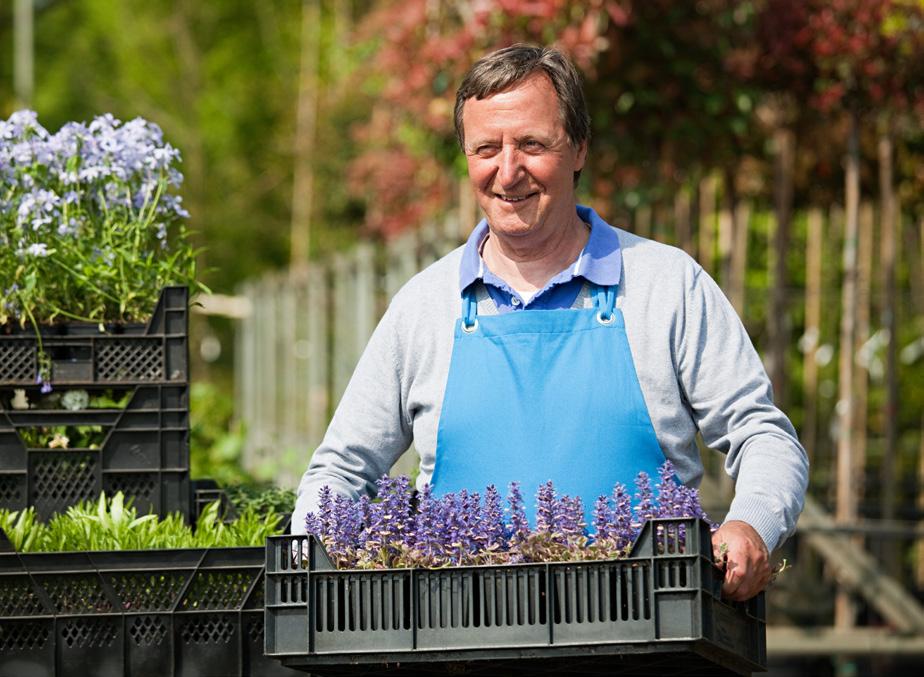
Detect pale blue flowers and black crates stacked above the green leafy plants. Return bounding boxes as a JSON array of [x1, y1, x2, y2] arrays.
[[0, 111, 204, 518]]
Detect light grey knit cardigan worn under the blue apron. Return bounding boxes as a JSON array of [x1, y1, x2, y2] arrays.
[[292, 224, 808, 550]]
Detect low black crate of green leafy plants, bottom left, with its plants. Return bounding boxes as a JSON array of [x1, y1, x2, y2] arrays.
[[0, 494, 299, 677]]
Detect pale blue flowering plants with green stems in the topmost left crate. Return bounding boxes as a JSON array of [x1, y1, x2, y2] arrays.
[[0, 110, 204, 386]]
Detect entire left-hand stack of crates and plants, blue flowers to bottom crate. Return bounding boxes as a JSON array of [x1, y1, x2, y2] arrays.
[[0, 111, 296, 677]]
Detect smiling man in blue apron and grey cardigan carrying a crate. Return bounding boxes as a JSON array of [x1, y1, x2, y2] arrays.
[[293, 45, 808, 600]]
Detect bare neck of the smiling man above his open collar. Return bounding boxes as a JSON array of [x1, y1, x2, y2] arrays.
[[481, 214, 590, 291]]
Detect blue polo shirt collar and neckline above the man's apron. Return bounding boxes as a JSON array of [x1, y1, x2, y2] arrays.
[[459, 205, 622, 313]]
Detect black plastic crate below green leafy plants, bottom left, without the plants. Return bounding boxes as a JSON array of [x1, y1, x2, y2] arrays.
[[0, 547, 304, 677]]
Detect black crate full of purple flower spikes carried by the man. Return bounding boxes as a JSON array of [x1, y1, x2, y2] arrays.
[[266, 464, 766, 675]]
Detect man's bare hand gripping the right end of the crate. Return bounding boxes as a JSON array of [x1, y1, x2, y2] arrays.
[[712, 520, 770, 602]]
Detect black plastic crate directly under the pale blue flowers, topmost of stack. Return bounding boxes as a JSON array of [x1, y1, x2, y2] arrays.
[[0, 287, 189, 388]]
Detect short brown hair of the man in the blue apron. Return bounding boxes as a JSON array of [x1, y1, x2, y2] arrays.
[[453, 43, 590, 149]]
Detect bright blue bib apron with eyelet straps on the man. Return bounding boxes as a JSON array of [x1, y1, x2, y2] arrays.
[[431, 286, 664, 525]]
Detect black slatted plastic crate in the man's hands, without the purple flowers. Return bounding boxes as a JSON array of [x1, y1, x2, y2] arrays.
[[266, 519, 766, 675]]
